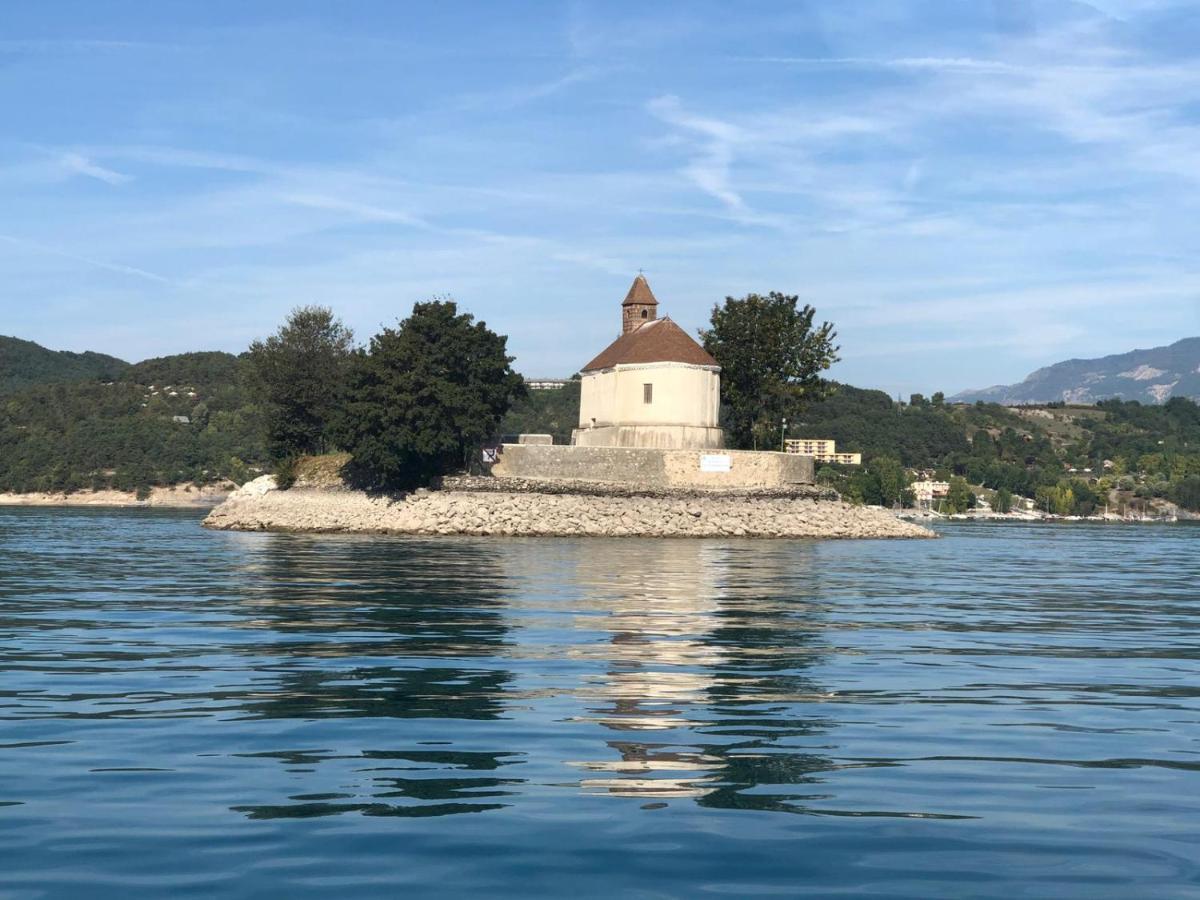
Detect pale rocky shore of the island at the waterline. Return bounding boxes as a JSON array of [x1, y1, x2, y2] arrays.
[[204, 476, 937, 539]]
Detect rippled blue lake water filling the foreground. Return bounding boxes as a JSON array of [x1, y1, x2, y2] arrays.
[[0, 509, 1200, 899]]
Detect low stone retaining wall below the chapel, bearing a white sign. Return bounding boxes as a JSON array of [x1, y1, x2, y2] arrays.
[[492, 444, 814, 491]]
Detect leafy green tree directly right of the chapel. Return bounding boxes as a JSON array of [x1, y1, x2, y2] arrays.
[[700, 290, 839, 448]]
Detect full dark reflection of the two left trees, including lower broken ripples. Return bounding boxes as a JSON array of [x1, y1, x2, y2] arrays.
[[224, 535, 523, 818]]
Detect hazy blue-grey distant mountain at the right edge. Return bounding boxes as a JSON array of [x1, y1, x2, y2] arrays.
[[950, 337, 1200, 406]]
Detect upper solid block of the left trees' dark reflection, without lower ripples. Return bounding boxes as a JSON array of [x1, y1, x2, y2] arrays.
[[230, 538, 511, 719]]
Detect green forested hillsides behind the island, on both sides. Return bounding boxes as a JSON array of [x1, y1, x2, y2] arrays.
[[0, 341, 1200, 512]]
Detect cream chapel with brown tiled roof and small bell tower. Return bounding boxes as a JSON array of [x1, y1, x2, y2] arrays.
[[572, 275, 724, 450]]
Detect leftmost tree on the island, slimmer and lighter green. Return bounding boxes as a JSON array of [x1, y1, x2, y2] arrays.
[[248, 306, 354, 460]]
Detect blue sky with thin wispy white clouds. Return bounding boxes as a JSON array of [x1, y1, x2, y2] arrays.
[[0, 0, 1200, 394]]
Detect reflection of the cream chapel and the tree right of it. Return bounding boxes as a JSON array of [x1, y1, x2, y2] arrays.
[[552, 541, 830, 810]]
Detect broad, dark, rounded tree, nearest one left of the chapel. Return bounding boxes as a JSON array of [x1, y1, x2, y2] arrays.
[[337, 300, 524, 488]]
